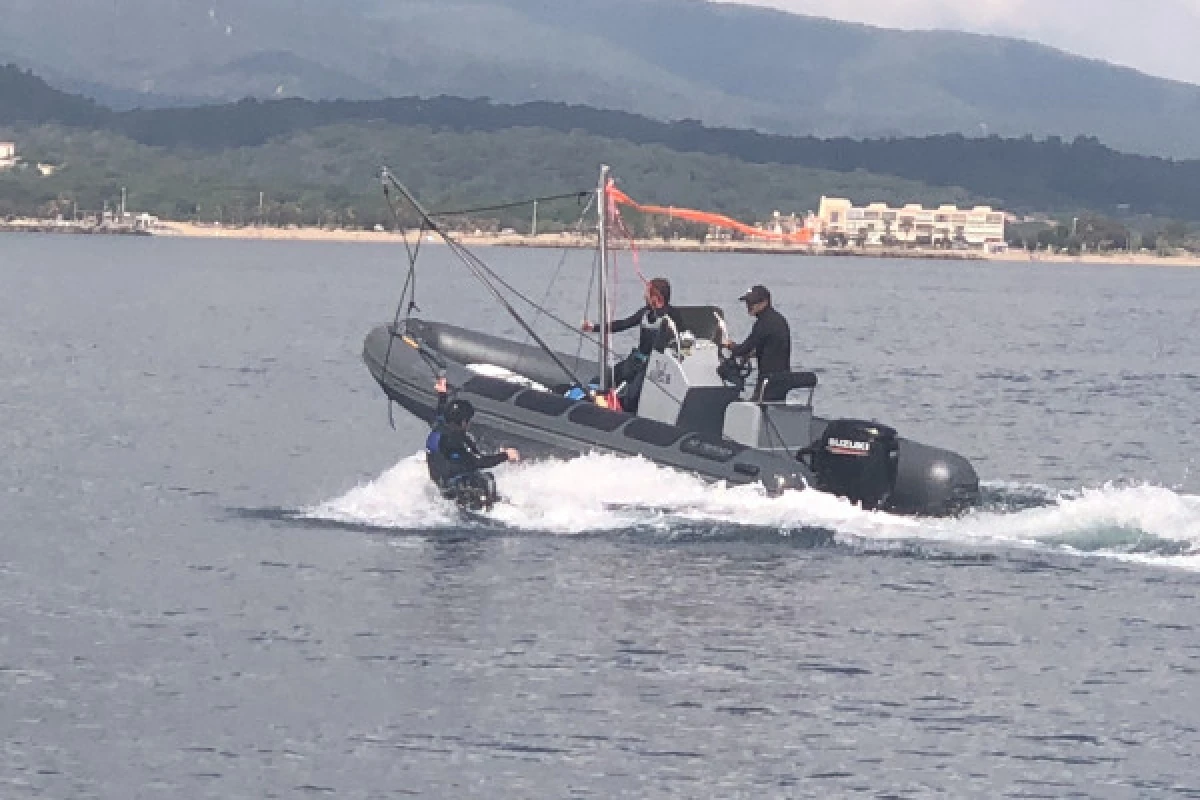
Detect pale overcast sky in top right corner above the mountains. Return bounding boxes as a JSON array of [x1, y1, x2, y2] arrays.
[[727, 0, 1200, 84]]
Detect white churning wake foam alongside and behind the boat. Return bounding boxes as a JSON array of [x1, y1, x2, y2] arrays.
[[306, 455, 1200, 569]]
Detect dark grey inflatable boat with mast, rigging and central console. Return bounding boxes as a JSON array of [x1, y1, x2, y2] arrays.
[[362, 168, 979, 516]]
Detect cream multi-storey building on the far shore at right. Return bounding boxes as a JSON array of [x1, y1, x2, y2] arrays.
[[816, 197, 1006, 248]]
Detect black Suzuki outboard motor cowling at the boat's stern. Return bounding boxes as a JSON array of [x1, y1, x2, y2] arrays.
[[811, 420, 900, 510]]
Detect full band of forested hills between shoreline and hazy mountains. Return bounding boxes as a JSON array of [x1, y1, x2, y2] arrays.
[[0, 68, 1200, 231]]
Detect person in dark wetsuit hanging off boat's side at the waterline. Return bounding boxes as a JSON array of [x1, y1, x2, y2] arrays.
[[425, 377, 521, 510]]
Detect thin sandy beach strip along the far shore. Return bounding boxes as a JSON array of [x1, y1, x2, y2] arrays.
[[7, 219, 1200, 266]]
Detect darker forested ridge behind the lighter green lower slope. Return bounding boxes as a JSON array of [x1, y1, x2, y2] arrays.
[[0, 62, 1200, 219]]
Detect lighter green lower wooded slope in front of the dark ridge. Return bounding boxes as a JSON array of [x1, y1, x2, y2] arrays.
[[0, 122, 979, 227]]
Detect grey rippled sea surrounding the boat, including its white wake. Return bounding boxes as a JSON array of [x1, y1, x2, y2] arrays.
[[0, 236, 1200, 799]]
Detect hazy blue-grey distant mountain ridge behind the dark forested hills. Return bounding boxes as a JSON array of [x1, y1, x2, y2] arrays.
[[7, 0, 1200, 157]]
